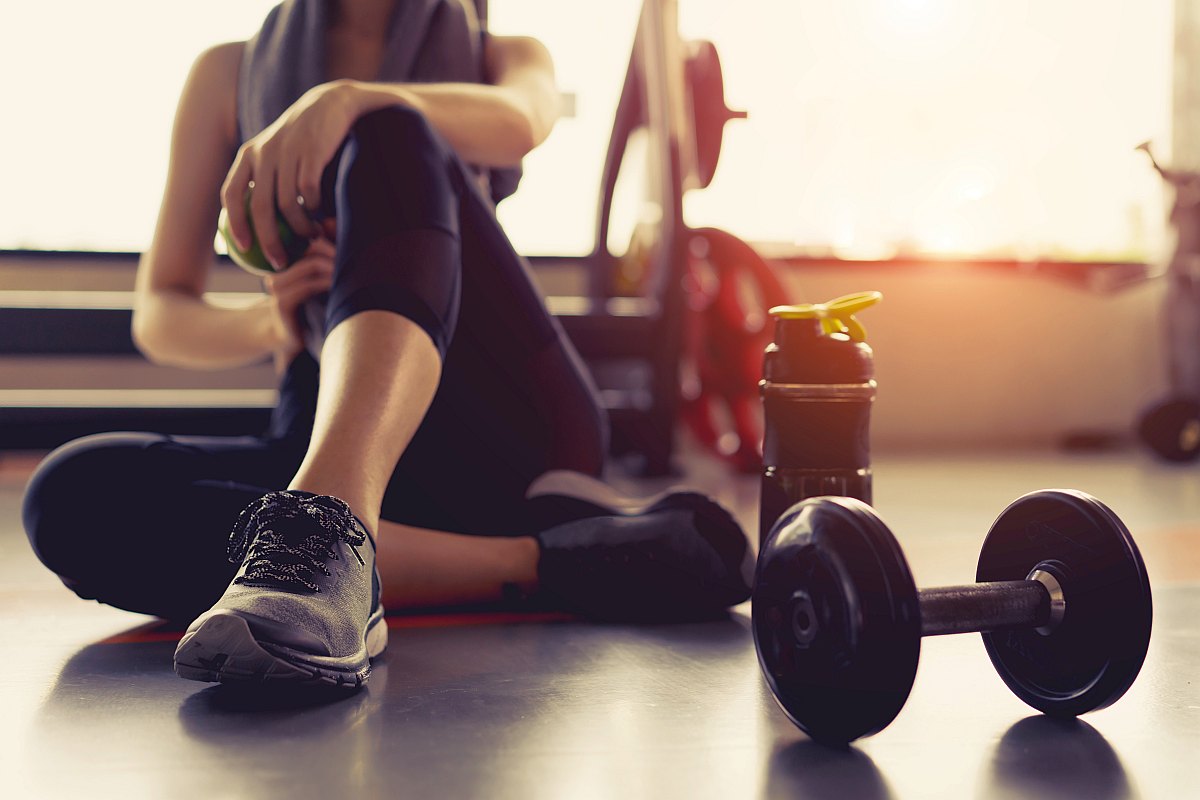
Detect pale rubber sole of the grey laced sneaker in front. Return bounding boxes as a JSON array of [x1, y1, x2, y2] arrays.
[[175, 608, 388, 688]]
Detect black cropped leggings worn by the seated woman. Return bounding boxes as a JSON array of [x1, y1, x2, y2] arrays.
[[23, 107, 607, 618]]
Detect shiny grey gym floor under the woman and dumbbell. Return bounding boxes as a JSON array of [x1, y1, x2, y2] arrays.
[[0, 443, 1200, 800]]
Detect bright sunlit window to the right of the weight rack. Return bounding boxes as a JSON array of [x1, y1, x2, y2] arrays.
[[679, 0, 1172, 260]]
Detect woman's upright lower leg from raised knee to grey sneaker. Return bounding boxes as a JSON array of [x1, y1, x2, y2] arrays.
[[175, 107, 561, 686]]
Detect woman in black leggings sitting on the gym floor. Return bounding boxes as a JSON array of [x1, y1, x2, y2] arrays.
[[24, 0, 750, 686]]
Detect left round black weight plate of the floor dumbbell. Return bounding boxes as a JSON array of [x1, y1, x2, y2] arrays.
[[752, 498, 920, 744]]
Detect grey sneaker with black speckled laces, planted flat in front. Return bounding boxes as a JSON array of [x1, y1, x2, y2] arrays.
[[175, 492, 388, 687]]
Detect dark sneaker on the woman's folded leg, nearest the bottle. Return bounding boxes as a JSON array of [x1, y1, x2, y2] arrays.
[[535, 479, 755, 622]]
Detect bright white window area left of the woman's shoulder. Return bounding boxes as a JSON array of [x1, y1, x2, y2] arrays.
[[0, 0, 275, 251]]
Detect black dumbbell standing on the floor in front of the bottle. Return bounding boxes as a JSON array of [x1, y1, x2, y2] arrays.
[[752, 489, 1152, 745]]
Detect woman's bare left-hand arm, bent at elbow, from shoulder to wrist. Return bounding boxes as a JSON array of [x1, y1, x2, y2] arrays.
[[133, 43, 278, 368]]
